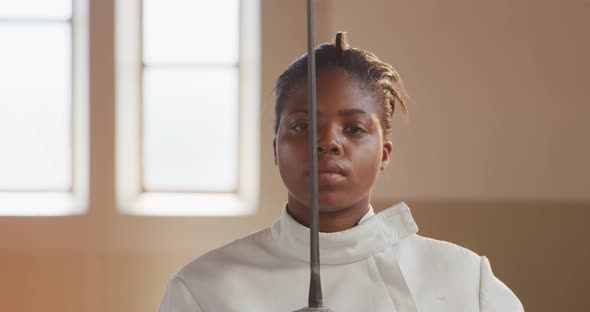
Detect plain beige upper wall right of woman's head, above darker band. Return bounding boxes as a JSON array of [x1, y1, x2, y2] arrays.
[[327, 0, 590, 201]]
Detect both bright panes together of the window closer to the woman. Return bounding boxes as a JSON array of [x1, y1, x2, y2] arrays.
[[142, 0, 239, 192]]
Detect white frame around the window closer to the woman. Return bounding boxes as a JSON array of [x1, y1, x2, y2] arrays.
[[115, 0, 260, 216]]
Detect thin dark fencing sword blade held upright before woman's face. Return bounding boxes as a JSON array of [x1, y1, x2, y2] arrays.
[[296, 0, 332, 312]]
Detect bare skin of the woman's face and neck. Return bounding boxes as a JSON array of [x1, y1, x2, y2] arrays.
[[273, 69, 392, 232]]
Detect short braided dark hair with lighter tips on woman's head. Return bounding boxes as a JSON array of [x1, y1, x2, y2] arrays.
[[274, 32, 407, 140]]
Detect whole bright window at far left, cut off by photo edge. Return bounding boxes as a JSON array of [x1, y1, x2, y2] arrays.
[[0, 0, 88, 215]]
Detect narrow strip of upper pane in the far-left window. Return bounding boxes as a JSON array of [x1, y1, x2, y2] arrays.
[[0, 0, 72, 19]]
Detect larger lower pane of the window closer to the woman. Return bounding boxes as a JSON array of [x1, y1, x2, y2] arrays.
[[143, 67, 238, 191]]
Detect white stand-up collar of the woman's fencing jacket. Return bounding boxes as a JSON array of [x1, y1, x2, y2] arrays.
[[271, 202, 418, 264]]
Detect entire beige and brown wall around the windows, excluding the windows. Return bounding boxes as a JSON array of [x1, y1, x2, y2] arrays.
[[0, 0, 590, 312]]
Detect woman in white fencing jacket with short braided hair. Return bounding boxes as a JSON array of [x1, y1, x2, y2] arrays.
[[160, 33, 523, 312]]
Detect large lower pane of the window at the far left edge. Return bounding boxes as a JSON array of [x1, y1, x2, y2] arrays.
[[0, 23, 72, 190]]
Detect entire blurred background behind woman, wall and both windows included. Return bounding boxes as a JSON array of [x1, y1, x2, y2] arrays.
[[0, 0, 590, 312]]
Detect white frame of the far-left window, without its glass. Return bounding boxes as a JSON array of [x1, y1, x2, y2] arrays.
[[0, 0, 89, 216]]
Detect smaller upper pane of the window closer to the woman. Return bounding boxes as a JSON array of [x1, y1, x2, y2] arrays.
[[143, 0, 239, 64]]
